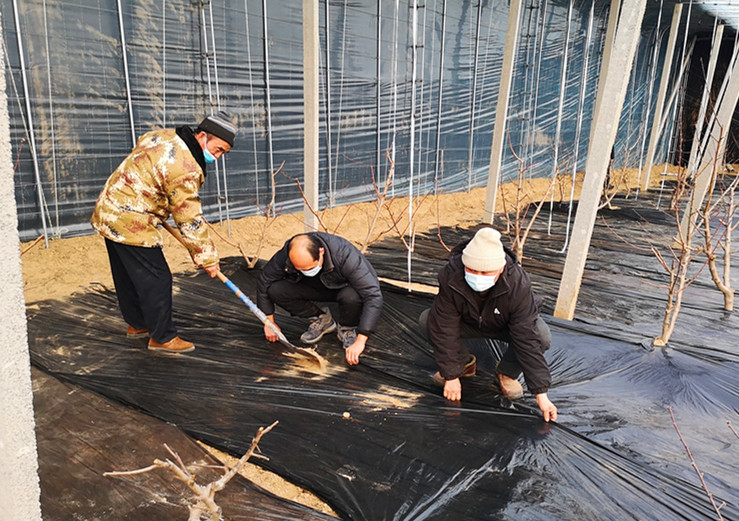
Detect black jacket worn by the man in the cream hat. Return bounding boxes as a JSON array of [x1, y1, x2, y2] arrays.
[[428, 243, 551, 394]]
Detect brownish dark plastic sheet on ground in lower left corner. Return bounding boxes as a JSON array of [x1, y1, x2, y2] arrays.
[[32, 368, 335, 521]]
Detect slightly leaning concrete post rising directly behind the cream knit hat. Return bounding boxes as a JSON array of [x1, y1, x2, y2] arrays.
[[483, 0, 521, 224]]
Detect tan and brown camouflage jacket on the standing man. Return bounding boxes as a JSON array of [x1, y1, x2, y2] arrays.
[[91, 129, 218, 266]]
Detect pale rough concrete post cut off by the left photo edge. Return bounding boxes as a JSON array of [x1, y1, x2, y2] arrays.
[[0, 10, 41, 521]]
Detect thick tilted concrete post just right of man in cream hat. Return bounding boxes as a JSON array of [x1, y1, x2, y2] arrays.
[[554, 0, 646, 320]]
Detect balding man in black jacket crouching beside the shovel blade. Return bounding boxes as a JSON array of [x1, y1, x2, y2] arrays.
[[257, 232, 382, 365]]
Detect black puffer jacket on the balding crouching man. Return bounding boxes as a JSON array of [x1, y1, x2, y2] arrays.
[[257, 232, 382, 336]]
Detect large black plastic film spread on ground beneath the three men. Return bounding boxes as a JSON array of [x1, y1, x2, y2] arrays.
[[29, 194, 739, 521]]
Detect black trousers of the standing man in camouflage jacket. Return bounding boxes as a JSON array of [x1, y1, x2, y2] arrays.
[[105, 239, 177, 343]]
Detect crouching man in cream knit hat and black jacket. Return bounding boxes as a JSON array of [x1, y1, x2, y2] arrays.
[[419, 228, 557, 421]]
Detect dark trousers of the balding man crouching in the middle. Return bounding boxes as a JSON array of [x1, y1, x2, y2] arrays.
[[267, 277, 362, 327]]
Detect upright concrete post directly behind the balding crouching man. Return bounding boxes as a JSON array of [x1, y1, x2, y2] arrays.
[[303, 0, 320, 232]]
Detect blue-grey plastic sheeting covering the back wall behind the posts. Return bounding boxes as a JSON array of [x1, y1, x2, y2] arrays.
[[0, 0, 684, 240]]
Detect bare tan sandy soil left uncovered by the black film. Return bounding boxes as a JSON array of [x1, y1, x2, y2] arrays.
[[20, 166, 664, 513]]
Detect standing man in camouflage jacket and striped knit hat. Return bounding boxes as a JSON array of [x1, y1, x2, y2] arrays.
[[91, 112, 236, 353]]
